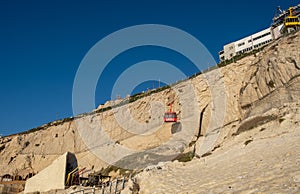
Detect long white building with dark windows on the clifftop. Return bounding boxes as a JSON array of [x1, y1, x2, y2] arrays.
[[219, 28, 273, 61]]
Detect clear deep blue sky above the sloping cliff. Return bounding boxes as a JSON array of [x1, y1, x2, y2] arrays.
[[0, 0, 299, 135]]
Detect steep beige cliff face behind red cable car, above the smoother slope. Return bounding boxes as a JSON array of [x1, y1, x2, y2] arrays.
[[0, 32, 300, 180]]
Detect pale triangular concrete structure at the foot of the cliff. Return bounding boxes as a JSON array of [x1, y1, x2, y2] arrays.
[[24, 152, 77, 193]]
